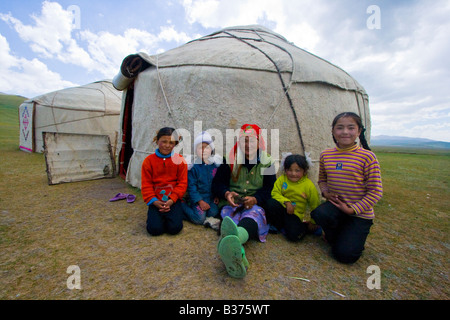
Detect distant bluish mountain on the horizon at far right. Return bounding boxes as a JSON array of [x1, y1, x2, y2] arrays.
[[370, 136, 450, 149]]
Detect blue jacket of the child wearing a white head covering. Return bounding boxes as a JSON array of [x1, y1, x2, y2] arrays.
[[187, 163, 218, 206]]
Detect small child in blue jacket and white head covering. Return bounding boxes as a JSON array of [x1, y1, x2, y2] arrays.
[[182, 131, 222, 224]]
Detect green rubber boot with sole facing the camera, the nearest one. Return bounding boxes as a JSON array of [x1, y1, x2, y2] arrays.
[[218, 235, 249, 279]]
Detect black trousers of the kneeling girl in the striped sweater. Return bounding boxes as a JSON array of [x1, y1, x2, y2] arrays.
[[311, 201, 373, 263]]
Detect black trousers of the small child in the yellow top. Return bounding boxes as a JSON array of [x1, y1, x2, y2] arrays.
[[265, 198, 308, 241]]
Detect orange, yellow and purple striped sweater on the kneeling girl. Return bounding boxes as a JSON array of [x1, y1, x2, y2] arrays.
[[319, 145, 383, 219]]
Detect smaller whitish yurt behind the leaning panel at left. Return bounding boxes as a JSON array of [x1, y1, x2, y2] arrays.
[[19, 80, 122, 152]]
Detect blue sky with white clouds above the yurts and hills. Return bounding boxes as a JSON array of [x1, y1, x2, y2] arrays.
[[0, 0, 450, 142]]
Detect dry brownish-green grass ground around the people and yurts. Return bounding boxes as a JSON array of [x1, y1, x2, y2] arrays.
[[0, 95, 450, 300]]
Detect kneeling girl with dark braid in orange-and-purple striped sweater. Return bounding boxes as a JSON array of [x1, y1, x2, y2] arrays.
[[311, 112, 383, 263]]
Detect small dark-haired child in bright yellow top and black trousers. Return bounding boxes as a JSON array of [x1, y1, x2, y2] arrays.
[[267, 154, 322, 241]]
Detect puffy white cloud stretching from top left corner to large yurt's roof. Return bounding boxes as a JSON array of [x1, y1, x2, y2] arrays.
[[0, 1, 197, 78]]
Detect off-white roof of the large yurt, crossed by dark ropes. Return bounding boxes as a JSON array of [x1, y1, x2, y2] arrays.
[[129, 25, 366, 95]]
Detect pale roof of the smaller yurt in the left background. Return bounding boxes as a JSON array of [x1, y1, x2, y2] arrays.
[[24, 80, 122, 114]]
